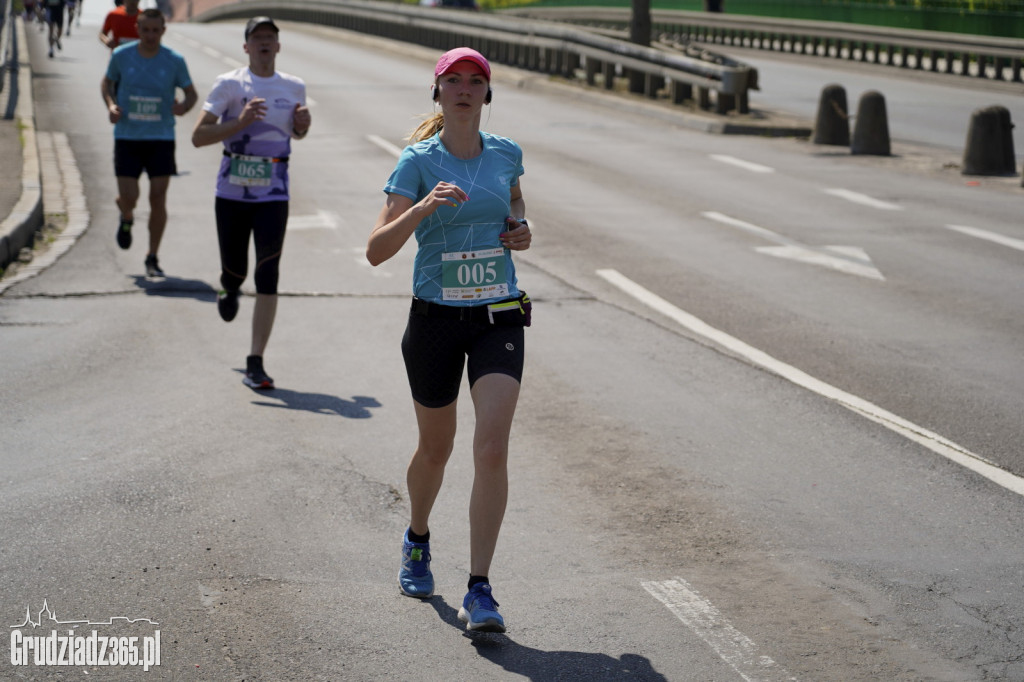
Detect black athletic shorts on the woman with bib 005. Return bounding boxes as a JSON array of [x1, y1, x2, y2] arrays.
[[401, 302, 525, 408]]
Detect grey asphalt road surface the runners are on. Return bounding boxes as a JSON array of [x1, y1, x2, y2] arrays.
[[0, 10, 1024, 681]]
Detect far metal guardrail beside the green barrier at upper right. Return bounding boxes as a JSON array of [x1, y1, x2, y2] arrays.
[[504, 7, 1024, 83]]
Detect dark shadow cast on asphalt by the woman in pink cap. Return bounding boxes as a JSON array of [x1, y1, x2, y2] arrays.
[[428, 595, 668, 682]]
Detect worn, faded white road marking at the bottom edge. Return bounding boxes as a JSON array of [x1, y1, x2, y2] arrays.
[[640, 578, 797, 682]]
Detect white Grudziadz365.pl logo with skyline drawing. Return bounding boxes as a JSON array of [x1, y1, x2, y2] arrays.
[[10, 600, 160, 672]]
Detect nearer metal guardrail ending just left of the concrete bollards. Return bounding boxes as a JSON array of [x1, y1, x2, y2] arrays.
[[184, 0, 757, 114]]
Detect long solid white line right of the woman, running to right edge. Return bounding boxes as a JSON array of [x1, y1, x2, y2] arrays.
[[597, 269, 1024, 496]]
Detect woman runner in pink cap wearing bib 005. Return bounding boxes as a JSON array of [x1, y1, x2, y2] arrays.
[[367, 47, 531, 632]]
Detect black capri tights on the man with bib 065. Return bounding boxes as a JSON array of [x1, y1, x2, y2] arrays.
[[214, 197, 288, 294]]
